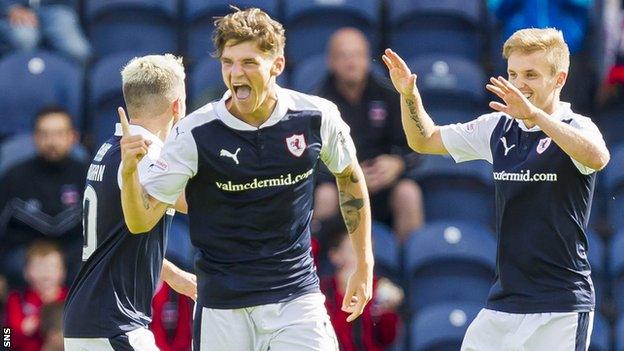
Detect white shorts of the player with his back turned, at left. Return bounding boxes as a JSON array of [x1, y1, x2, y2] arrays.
[[65, 328, 159, 351]]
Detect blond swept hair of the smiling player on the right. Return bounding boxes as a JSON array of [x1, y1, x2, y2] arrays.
[[503, 28, 570, 75]]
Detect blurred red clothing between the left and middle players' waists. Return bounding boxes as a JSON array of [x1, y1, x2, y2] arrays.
[[150, 283, 193, 351]]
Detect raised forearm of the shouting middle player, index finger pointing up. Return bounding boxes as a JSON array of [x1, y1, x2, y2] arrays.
[[117, 107, 170, 234]]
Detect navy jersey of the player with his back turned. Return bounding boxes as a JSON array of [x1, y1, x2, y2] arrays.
[[63, 124, 172, 338]]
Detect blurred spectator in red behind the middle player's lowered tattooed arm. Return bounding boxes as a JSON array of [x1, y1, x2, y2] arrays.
[[321, 225, 403, 351]]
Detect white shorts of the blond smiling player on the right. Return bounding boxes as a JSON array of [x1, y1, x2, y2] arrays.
[[461, 309, 594, 351]]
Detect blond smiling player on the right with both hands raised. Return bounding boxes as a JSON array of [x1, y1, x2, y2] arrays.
[[383, 29, 609, 351]]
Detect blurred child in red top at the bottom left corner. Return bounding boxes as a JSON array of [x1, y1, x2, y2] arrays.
[[5, 241, 67, 351]]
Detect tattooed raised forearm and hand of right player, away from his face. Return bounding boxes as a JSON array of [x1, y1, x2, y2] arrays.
[[382, 49, 448, 155]]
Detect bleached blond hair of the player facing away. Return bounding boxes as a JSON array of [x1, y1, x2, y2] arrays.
[[121, 54, 186, 116]]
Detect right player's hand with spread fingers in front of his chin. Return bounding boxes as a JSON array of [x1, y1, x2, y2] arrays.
[[485, 76, 538, 120]]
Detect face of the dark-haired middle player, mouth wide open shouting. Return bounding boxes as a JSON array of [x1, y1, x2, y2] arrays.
[[221, 41, 284, 115]]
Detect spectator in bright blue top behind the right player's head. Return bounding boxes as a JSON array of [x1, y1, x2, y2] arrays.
[[488, 0, 599, 114]]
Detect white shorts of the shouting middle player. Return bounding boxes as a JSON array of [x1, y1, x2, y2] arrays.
[[193, 293, 338, 351]]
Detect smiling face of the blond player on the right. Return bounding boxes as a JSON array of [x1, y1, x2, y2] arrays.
[[507, 51, 566, 110]]
